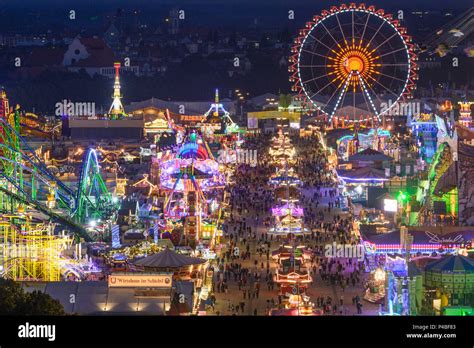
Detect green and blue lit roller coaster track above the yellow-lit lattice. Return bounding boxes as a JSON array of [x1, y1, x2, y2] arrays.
[[0, 91, 118, 241]]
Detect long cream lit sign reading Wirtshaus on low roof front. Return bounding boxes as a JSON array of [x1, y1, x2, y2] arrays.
[[109, 274, 172, 288]]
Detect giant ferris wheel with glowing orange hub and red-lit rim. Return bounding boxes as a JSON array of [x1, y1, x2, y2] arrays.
[[289, 3, 418, 122]]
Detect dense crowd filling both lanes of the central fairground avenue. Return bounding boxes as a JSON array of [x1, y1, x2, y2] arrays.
[[208, 130, 370, 315]]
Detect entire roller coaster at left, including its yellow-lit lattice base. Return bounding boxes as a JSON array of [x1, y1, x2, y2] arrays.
[[0, 91, 118, 280]]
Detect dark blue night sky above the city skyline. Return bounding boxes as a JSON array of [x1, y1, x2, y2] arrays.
[[0, 0, 473, 30]]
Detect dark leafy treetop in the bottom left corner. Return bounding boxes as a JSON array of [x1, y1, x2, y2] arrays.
[[0, 278, 66, 315]]
